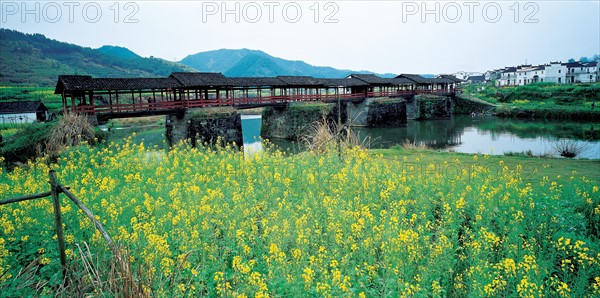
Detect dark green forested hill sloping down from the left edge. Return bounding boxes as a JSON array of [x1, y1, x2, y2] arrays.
[[0, 29, 194, 86]]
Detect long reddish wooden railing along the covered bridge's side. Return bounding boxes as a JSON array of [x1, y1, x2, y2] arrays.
[[71, 89, 453, 114]]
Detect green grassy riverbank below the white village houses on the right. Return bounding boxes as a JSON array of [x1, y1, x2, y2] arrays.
[[464, 83, 600, 121]]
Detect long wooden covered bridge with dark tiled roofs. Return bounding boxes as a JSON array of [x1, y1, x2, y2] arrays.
[[55, 72, 460, 118]]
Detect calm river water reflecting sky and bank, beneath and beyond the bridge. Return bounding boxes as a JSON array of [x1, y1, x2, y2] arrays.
[[242, 115, 600, 159]]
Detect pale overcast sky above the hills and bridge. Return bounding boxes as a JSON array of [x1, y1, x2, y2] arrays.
[[0, 0, 600, 73]]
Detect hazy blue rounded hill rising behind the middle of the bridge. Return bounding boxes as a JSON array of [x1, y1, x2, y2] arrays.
[[179, 49, 394, 78]]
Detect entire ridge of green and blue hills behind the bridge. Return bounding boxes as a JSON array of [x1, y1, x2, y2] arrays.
[[0, 29, 412, 86]]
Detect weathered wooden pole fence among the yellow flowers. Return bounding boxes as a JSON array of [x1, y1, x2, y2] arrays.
[[0, 170, 117, 278]]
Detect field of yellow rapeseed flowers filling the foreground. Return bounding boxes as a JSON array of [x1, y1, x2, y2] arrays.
[[0, 141, 600, 297]]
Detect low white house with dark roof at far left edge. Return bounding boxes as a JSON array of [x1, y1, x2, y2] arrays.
[[0, 101, 49, 124]]
